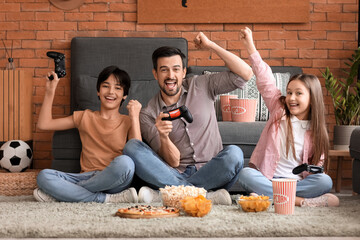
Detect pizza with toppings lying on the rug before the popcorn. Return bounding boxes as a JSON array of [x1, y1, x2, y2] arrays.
[[115, 205, 179, 218]]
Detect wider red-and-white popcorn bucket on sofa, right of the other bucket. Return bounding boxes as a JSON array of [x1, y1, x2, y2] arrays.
[[230, 99, 257, 122]]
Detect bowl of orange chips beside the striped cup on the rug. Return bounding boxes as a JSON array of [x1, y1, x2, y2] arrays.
[[237, 195, 271, 212]]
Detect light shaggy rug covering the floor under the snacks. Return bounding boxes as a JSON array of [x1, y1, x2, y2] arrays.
[[0, 196, 360, 238]]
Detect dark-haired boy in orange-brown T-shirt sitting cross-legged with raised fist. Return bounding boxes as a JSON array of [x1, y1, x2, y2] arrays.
[[34, 66, 141, 203]]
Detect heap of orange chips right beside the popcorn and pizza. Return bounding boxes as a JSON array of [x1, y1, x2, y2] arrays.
[[180, 195, 212, 217]]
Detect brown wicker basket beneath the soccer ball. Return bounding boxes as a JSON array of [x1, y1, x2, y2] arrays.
[[0, 169, 40, 196]]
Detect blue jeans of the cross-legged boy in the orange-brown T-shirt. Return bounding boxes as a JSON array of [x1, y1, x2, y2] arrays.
[[37, 155, 135, 203]]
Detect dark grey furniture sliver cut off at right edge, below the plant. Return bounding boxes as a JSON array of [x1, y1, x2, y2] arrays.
[[349, 127, 360, 194]]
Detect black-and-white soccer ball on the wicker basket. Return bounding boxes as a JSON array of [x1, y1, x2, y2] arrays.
[[0, 140, 32, 172]]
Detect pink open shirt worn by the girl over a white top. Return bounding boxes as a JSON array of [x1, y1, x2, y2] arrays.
[[249, 52, 323, 179]]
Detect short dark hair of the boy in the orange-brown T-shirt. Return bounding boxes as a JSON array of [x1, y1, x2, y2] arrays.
[[96, 66, 131, 106]]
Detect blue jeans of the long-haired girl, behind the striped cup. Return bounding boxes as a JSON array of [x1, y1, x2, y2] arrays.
[[239, 167, 332, 198]]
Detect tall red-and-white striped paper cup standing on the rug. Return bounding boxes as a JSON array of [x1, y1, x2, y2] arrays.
[[272, 178, 297, 214]]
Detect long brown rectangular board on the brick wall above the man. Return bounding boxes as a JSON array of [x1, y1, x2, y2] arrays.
[[137, 0, 310, 23]]
